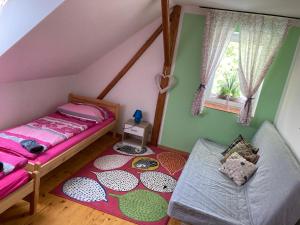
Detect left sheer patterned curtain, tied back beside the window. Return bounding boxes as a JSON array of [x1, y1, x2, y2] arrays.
[[192, 10, 239, 116]]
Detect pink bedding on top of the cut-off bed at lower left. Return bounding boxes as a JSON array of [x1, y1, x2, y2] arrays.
[[0, 152, 28, 179]]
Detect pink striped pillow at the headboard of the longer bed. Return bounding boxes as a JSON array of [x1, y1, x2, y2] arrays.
[[57, 103, 109, 123]]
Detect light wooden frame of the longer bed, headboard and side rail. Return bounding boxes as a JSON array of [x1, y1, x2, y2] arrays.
[[26, 94, 120, 177]]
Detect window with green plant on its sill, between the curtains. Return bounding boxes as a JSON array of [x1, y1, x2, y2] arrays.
[[205, 32, 260, 114]]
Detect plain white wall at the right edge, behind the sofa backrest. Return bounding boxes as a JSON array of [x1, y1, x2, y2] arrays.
[[276, 39, 300, 161]]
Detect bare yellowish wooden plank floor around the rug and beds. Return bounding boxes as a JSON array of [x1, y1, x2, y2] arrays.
[[0, 135, 180, 225]]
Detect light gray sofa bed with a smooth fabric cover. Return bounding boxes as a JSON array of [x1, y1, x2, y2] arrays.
[[168, 122, 300, 225]]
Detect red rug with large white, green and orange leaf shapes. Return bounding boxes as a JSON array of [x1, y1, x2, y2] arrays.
[[52, 143, 188, 225]]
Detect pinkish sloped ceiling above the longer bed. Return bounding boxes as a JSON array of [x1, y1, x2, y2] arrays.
[[0, 0, 165, 82]]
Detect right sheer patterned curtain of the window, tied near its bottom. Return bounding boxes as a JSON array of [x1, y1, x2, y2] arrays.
[[239, 14, 289, 125]]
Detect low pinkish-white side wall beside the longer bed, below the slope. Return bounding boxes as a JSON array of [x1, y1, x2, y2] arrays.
[[0, 76, 78, 129]]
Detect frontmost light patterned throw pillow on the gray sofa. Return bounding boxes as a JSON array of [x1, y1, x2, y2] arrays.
[[219, 152, 257, 186]]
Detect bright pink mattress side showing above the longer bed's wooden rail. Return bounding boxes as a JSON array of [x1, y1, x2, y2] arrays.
[[29, 117, 115, 164]]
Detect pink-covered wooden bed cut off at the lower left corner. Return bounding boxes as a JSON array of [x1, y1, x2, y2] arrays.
[[0, 152, 40, 214]]
